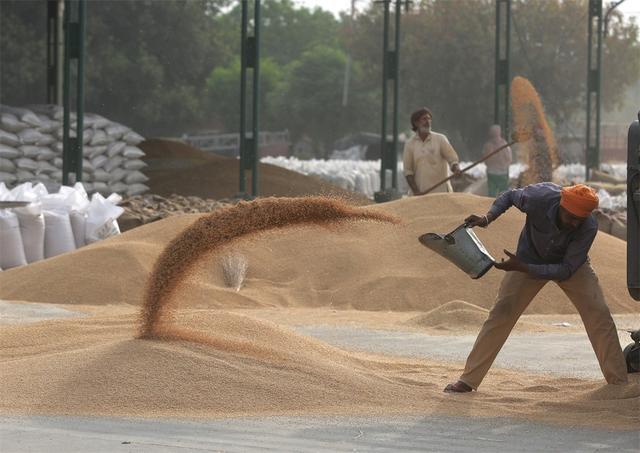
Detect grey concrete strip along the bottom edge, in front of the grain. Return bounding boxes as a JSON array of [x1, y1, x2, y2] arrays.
[[0, 416, 640, 453]]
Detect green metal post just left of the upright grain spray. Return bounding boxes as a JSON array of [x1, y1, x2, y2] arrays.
[[493, 0, 511, 137]]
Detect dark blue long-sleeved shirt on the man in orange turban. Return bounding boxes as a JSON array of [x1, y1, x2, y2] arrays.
[[489, 182, 598, 281]]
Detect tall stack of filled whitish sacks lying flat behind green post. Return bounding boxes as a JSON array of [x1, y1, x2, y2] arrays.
[[0, 105, 149, 196]]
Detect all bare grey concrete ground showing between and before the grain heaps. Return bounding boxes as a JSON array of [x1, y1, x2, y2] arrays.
[[0, 301, 640, 453]]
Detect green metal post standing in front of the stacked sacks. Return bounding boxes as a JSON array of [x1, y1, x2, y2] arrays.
[[62, 0, 86, 185]]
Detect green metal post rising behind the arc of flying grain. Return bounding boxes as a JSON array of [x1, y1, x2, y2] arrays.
[[240, 0, 260, 197]]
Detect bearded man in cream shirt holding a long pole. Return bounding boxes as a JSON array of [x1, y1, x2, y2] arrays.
[[403, 107, 460, 195]]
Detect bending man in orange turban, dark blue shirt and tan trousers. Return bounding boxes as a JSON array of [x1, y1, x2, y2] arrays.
[[445, 182, 627, 393]]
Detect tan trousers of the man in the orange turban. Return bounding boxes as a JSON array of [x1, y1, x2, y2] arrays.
[[460, 262, 627, 389]]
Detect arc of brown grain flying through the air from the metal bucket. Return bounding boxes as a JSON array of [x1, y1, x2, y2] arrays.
[[140, 197, 399, 340]]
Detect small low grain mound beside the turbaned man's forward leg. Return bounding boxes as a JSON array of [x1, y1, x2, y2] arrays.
[[407, 300, 489, 330]]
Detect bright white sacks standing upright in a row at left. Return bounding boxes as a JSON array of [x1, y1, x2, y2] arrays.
[[0, 182, 124, 270]]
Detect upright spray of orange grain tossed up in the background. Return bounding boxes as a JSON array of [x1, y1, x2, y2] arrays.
[[511, 77, 560, 186]]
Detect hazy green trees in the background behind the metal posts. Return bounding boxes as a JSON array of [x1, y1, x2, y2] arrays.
[[0, 0, 640, 160]]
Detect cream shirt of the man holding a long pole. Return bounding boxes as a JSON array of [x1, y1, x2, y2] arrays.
[[403, 132, 458, 193]]
